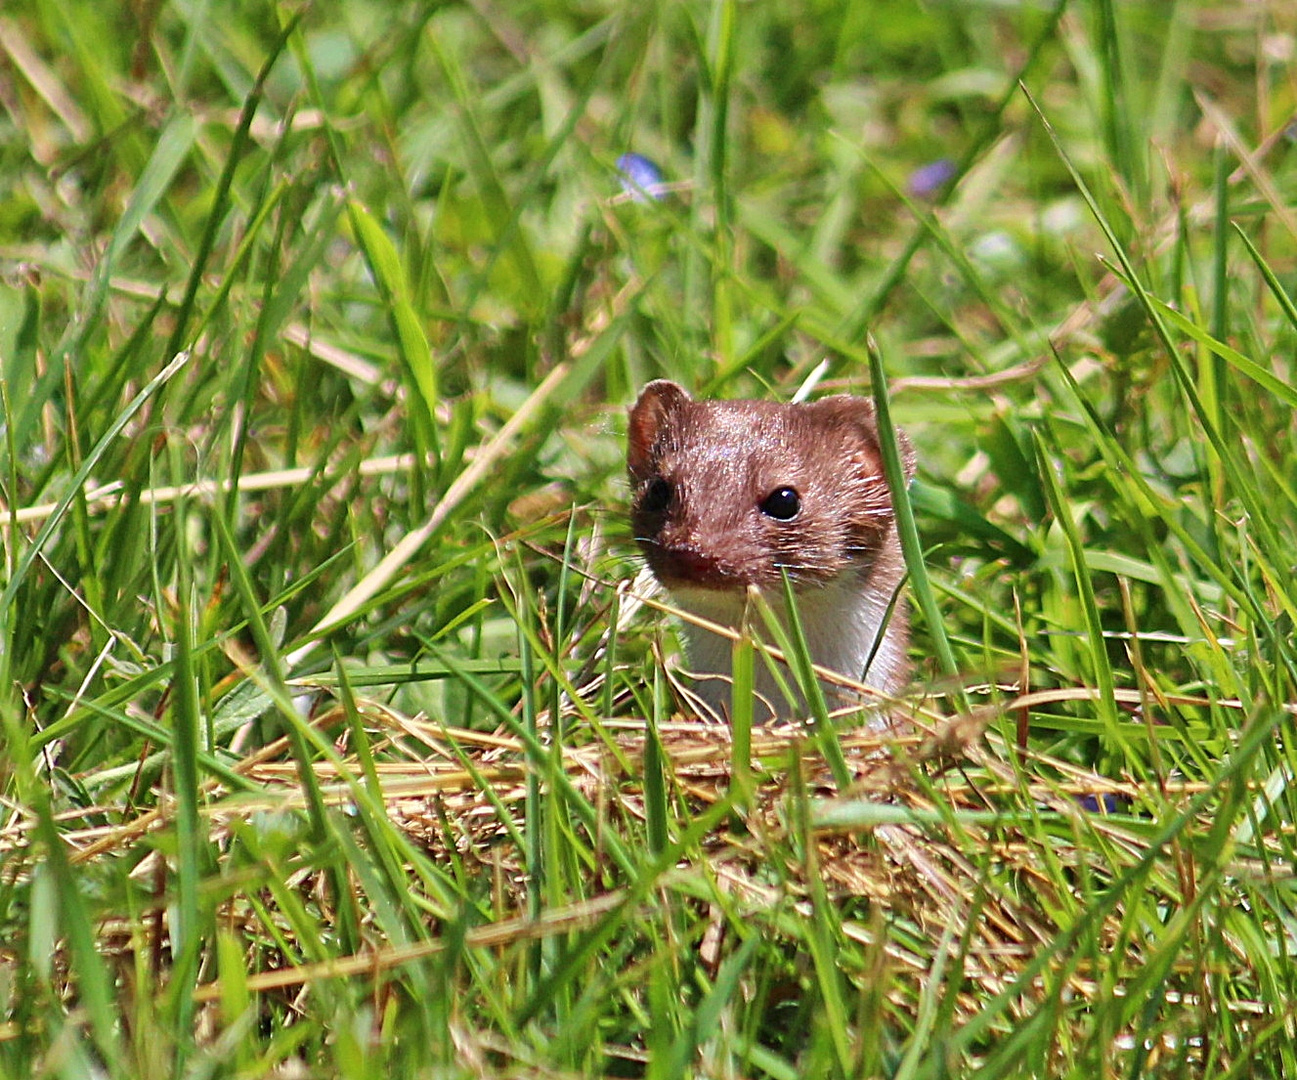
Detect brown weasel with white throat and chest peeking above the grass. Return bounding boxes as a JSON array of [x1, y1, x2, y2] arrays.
[[626, 379, 914, 714]]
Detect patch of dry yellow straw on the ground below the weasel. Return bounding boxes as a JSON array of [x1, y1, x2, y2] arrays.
[[0, 684, 1219, 1037]]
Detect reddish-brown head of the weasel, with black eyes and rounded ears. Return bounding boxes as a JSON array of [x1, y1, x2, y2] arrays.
[[626, 380, 914, 593]]
